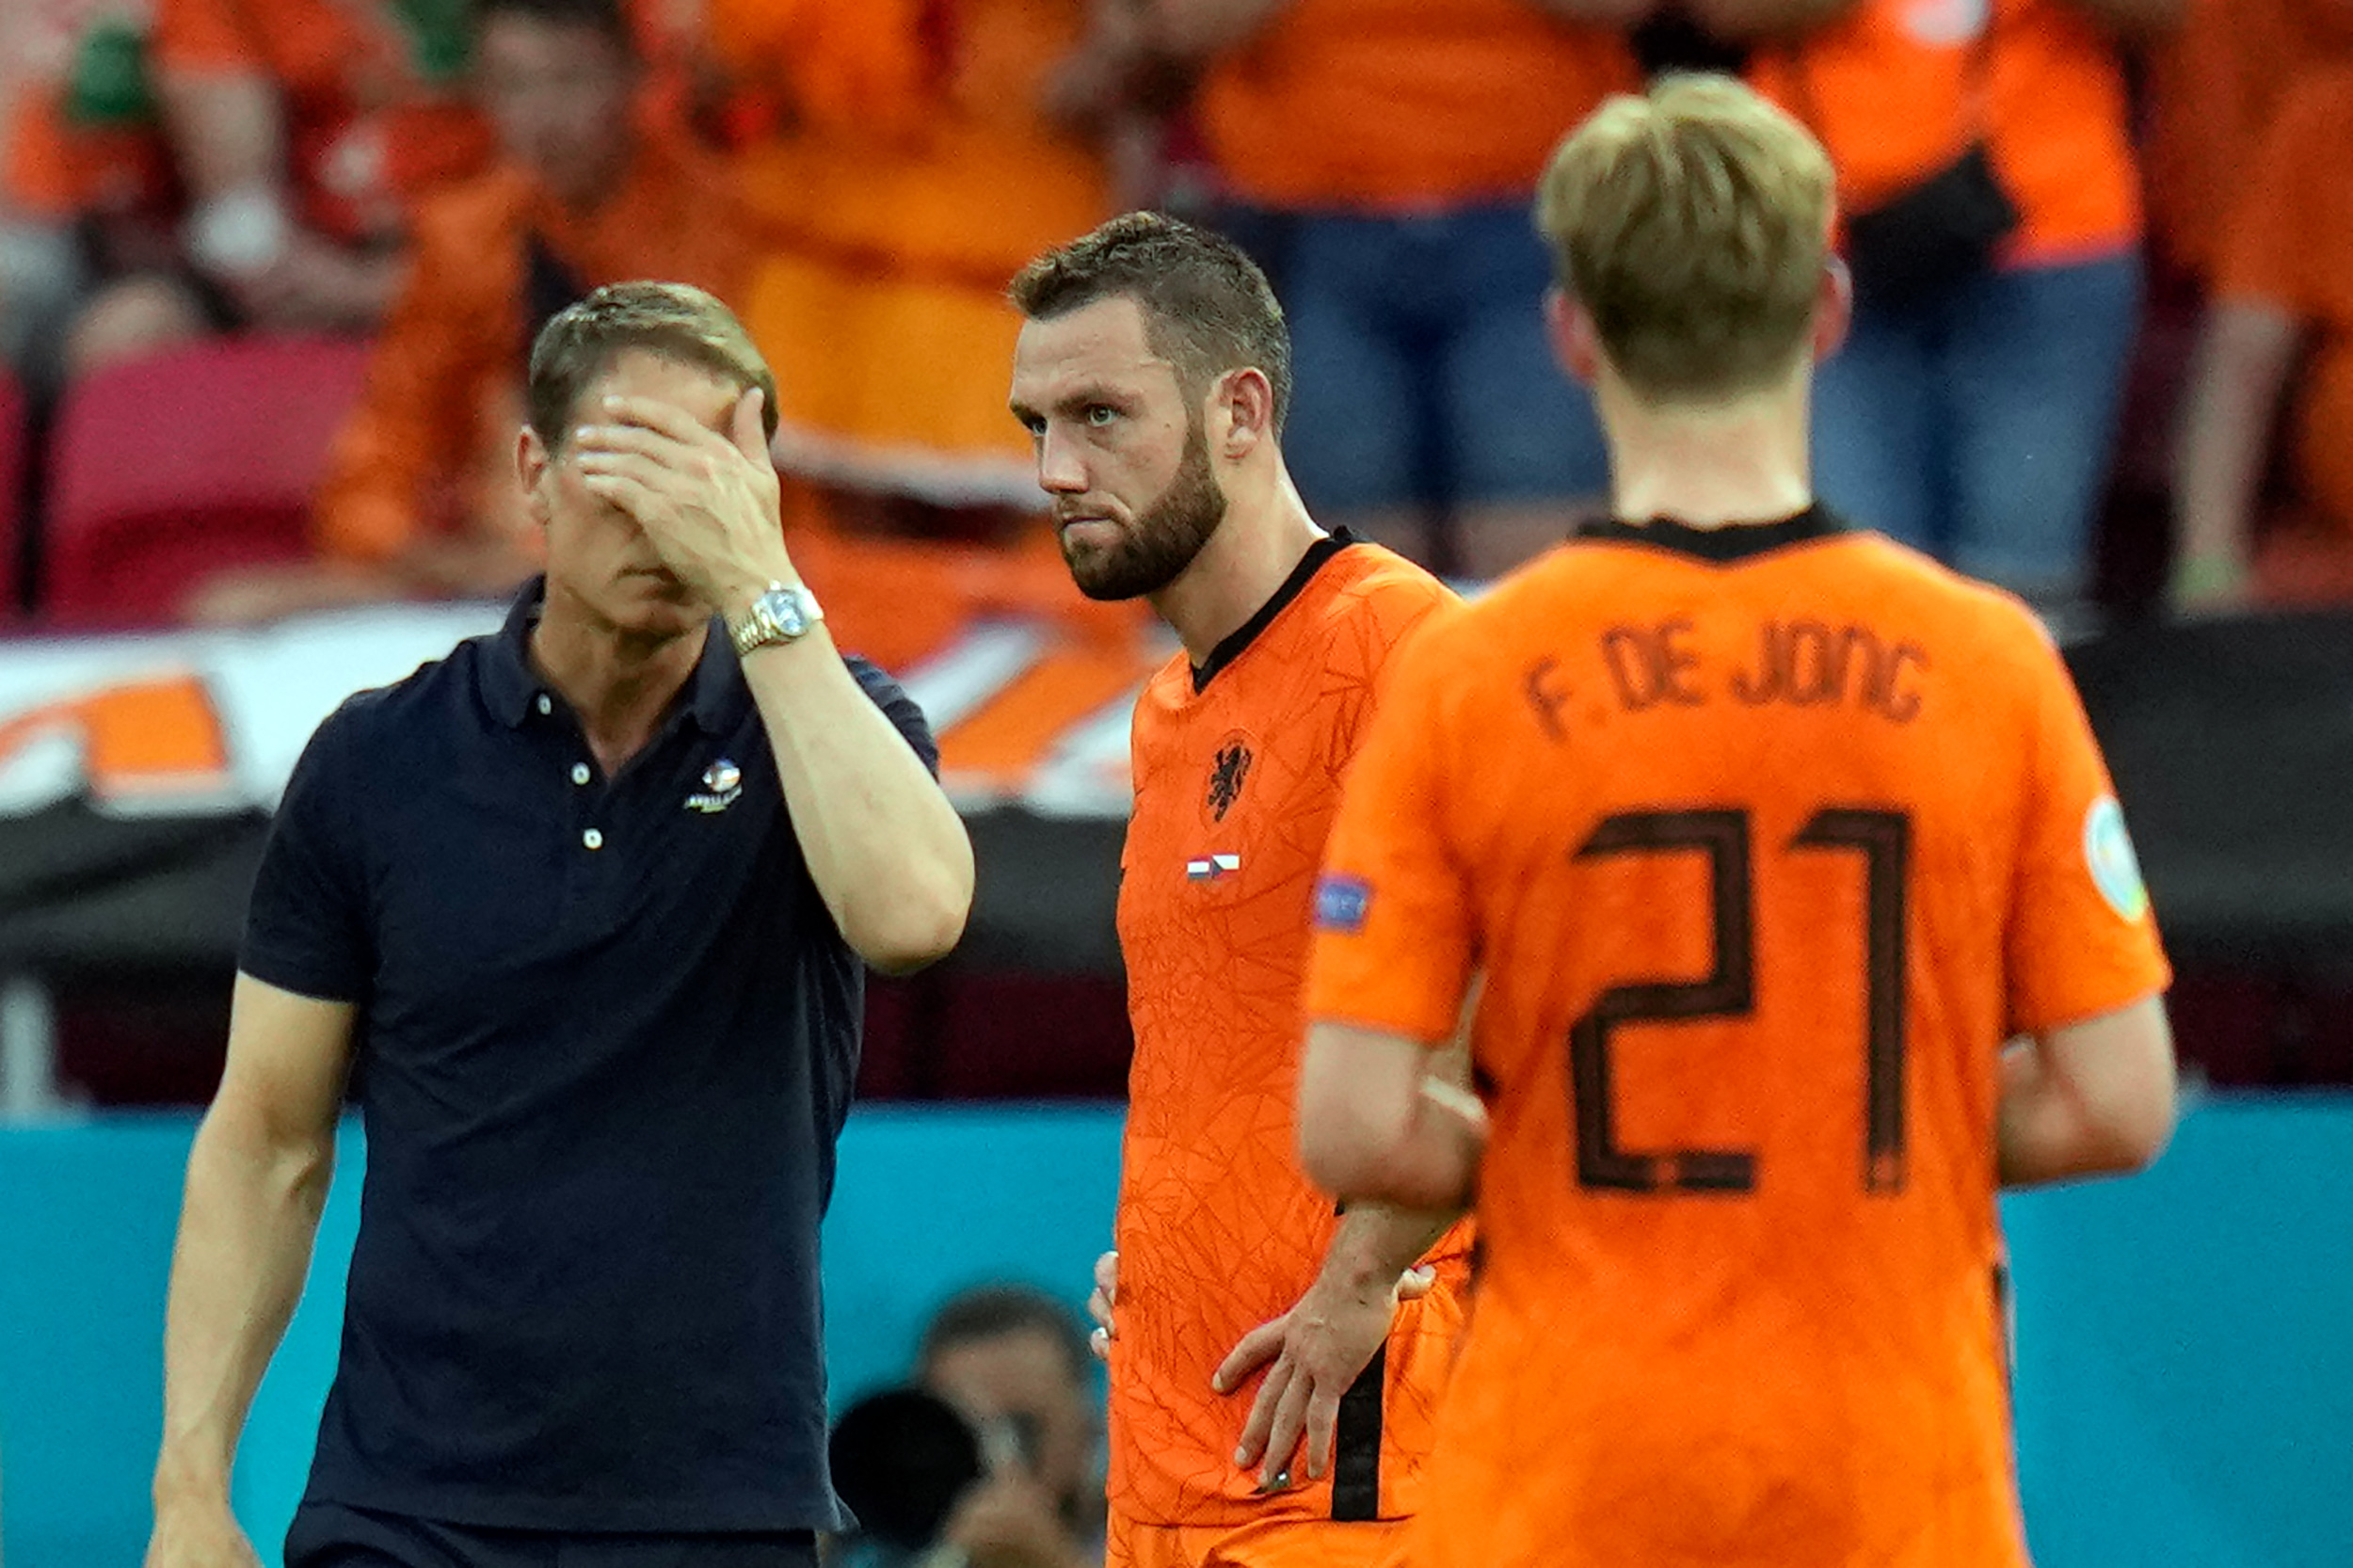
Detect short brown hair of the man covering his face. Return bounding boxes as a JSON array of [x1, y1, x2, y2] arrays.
[[527, 282, 776, 452]]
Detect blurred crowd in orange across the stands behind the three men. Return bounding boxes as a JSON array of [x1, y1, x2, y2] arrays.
[[0, 0, 2353, 640]]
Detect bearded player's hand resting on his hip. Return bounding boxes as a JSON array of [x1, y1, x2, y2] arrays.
[[1209, 1269, 1393, 1493]]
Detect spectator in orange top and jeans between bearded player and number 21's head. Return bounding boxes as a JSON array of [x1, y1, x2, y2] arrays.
[[1151, 0, 1652, 577]]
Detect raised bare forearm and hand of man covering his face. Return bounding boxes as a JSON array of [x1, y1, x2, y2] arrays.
[[574, 389, 972, 975]]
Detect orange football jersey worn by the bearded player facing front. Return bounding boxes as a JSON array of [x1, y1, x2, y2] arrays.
[[1111, 535, 1466, 1526]]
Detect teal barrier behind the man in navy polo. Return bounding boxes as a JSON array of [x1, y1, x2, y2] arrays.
[[0, 1107, 1120, 1568]]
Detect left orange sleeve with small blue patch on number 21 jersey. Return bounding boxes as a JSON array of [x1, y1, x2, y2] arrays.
[[1306, 635, 1473, 1046]]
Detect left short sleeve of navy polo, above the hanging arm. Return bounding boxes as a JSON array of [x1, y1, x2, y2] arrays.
[[238, 704, 376, 1000]]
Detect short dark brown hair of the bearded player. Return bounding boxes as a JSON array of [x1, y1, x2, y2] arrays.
[[1010, 212, 1292, 433]]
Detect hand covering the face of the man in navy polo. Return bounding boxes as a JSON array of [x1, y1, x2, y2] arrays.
[[572, 389, 795, 615]]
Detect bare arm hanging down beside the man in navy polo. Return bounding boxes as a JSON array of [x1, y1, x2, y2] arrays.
[[146, 975, 353, 1568]]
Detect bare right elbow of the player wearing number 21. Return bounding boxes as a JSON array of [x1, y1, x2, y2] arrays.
[[1995, 996, 2174, 1187]]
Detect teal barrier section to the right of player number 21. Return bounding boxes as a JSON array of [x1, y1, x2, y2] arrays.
[[2003, 1095, 2353, 1568]]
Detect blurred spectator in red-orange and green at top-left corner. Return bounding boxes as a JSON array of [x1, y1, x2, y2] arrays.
[[0, 0, 172, 391]]
